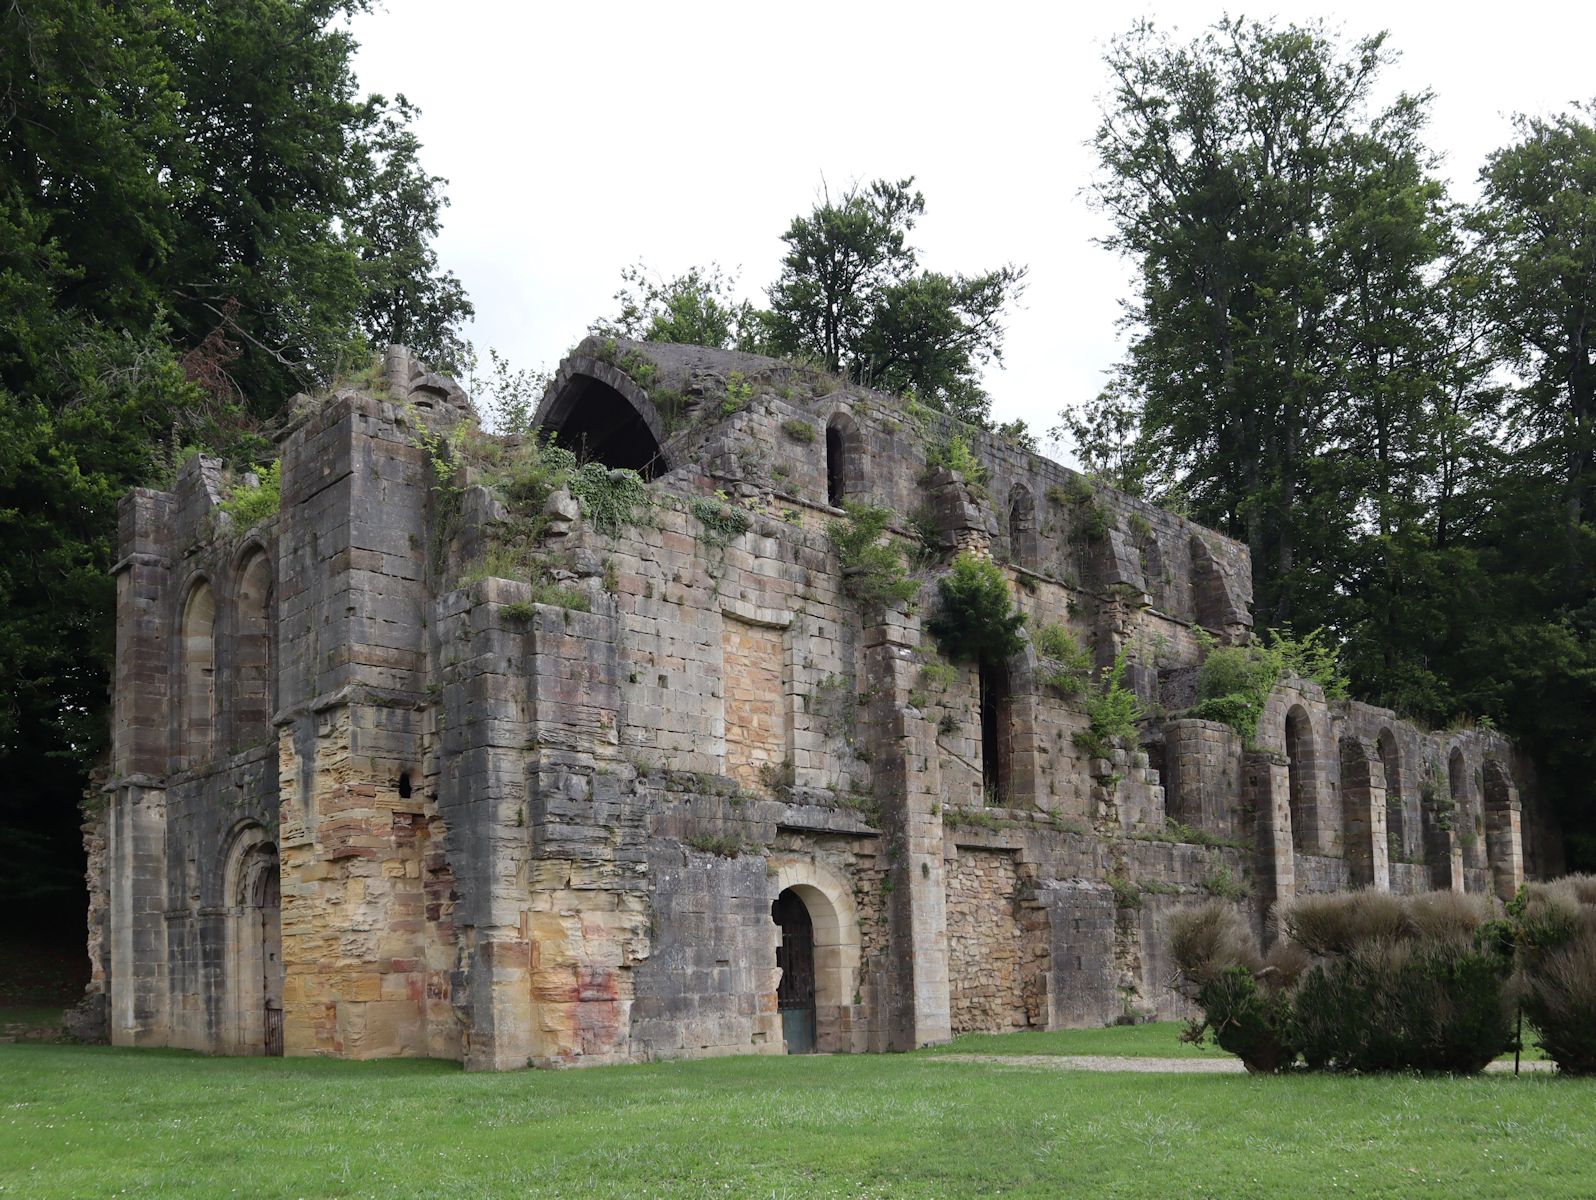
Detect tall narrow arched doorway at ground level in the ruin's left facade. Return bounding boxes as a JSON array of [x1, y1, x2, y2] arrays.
[[222, 825, 282, 1055]]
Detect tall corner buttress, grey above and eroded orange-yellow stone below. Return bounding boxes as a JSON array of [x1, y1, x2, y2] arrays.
[[275, 393, 434, 1058]]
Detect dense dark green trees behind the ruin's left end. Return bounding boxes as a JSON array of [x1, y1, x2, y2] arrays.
[[0, 0, 471, 911]]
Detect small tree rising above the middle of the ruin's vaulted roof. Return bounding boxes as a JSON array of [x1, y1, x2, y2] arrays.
[[763, 179, 1025, 424]]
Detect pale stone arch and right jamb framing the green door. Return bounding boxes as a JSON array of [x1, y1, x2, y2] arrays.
[[771, 859, 862, 1053]]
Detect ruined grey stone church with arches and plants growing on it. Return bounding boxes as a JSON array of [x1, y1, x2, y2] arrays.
[[85, 338, 1561, 1069]]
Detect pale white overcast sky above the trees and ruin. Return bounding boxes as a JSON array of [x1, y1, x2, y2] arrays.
[[354, 0, 1596, 453]]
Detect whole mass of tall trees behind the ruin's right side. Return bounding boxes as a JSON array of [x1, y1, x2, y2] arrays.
[[1063, 19, 1596, 863]]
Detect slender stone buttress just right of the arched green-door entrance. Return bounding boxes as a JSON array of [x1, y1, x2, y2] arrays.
[[863, 611, 953, 1050]]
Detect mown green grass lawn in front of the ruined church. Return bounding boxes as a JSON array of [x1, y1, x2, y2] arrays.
[[0, 1026, 1596, 1200]]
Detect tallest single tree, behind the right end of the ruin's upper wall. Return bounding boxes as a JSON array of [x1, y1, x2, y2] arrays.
[[1077, 19, 1440, 624]]
